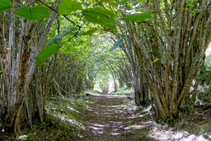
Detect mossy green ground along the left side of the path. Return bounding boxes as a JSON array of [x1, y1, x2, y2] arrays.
[[0, 97, 85, 141]]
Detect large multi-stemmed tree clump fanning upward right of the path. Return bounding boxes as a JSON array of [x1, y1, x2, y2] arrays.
[[110, 0, 211, 120]]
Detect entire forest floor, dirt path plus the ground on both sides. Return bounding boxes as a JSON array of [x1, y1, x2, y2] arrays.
[[0, 94, 211, 141]]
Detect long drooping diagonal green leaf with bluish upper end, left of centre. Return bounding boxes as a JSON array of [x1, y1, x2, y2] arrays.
[[35, 29, 72, 66]]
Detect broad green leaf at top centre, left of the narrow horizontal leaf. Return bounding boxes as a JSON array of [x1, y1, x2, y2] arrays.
[[82, 7, 116, 29]]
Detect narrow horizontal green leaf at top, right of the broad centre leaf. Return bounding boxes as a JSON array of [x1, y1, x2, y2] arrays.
[[120, 13, 152, 22]]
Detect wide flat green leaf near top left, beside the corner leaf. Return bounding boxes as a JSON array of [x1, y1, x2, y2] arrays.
[[15, 6, 48, 20]]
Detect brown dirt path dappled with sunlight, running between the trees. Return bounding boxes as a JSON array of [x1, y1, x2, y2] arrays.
[[78, 94, 153, 141]]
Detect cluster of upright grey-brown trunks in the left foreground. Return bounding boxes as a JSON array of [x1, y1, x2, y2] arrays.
[[0, 0, 61, 135]]
